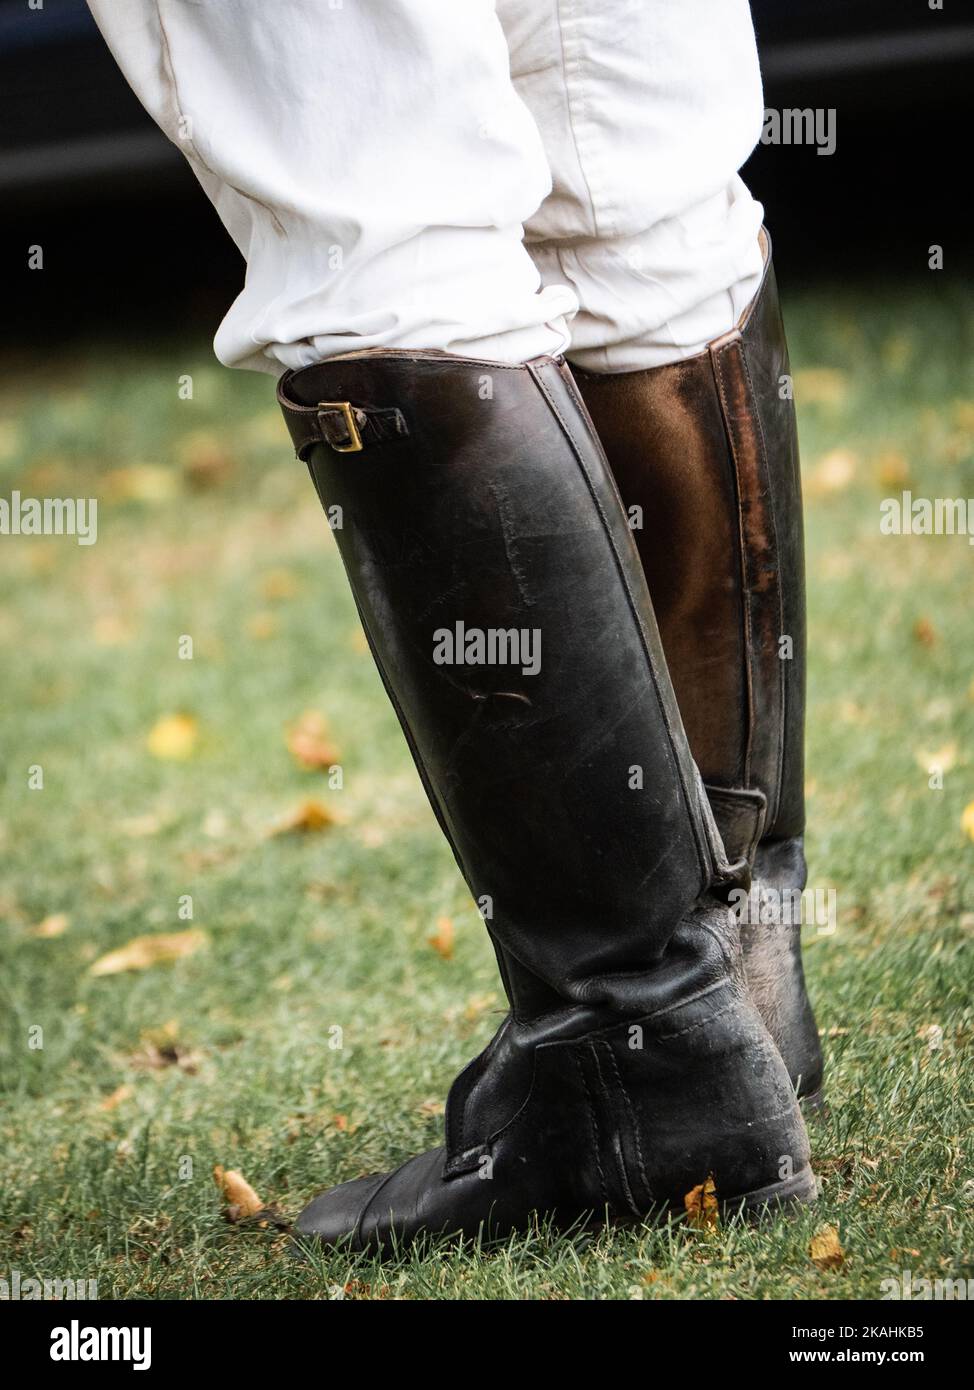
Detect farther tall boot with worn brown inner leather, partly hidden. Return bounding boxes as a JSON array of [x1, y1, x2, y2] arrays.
[[575, 232, 823, 1108]]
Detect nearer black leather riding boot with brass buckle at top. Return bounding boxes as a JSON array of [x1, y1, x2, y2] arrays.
[[279, 344, 814, 1251]]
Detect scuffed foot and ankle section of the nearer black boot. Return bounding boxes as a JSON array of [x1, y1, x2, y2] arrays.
[[296, 904, 816, 1252]]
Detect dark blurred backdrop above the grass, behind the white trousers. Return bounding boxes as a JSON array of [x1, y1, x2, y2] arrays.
[[0, 0, 974, 346]]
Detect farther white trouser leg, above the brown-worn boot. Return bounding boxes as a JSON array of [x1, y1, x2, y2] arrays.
[[497, 0, 763, 371]]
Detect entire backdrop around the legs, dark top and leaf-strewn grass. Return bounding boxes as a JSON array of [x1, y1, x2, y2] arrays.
[[0, 0, 974, 1298]]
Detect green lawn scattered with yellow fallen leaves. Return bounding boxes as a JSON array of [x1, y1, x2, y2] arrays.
[[0, 277, 974, 1298]]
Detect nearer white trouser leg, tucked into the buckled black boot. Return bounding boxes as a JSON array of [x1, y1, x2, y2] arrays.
[[89, 0, 575, 371]]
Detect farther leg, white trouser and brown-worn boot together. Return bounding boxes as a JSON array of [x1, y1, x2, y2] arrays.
[[500, 0, 821, 1097]]
